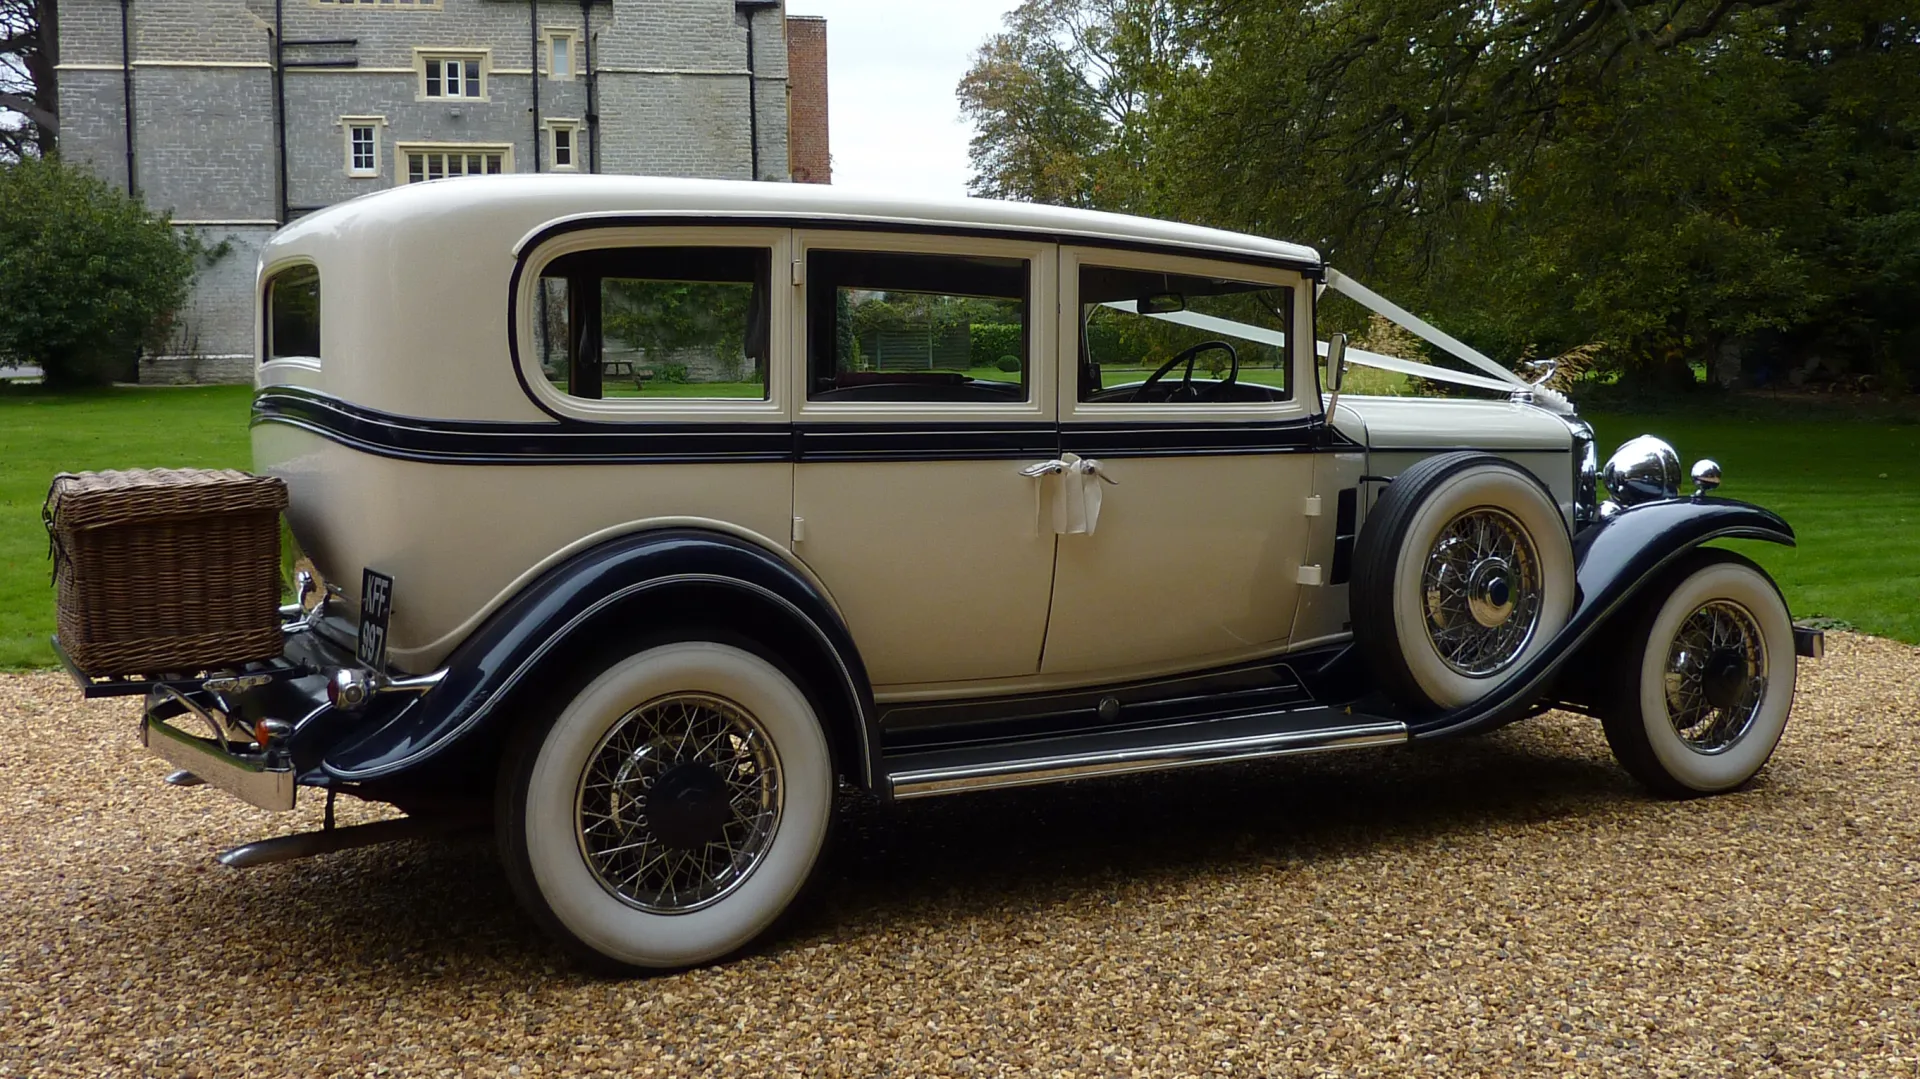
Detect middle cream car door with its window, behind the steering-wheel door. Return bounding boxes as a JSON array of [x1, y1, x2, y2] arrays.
[[793, 230, 1058, 687]]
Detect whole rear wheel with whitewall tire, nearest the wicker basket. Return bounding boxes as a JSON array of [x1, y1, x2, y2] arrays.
[[499, 641, 833, 970]]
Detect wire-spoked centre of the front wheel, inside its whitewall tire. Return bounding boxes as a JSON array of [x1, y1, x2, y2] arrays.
[[1665, 599, 1766, 755]]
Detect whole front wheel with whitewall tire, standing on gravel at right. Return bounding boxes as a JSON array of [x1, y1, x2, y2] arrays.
[[1601, 551, 1797, 797]]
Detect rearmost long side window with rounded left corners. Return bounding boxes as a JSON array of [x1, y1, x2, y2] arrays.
[[534, 248, 774, 401]]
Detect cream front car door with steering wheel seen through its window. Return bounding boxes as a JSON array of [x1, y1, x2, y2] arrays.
[[1041, 248, 1317, 680]]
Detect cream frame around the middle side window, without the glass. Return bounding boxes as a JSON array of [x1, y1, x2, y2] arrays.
[[791, 228, 1060, 422]]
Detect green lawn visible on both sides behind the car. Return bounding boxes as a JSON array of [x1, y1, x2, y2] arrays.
[[0, 378, 1920, 670]]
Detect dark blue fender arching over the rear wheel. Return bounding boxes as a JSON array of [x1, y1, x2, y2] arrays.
[[321, 528, 879, 787]]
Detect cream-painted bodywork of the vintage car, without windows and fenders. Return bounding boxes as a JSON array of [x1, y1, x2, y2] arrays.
[[253, 177, 1576, 683]]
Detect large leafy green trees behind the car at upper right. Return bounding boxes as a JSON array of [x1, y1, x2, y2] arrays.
[[960, 0, 1920, 384]]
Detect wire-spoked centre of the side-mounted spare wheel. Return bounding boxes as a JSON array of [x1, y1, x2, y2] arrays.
[[1421, 507, 1542, 678]]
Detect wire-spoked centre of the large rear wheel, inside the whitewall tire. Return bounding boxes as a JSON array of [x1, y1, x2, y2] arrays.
[[574, 693, 781, 914]]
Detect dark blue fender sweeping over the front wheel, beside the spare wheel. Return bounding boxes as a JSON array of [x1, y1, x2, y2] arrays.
[[1407, 497, 1793, 739]]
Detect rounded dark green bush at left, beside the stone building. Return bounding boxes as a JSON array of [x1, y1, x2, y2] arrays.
[[0, 157, 202, 386]]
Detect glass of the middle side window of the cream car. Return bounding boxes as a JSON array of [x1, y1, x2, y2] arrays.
[[806, 250, 1031, 403]]
